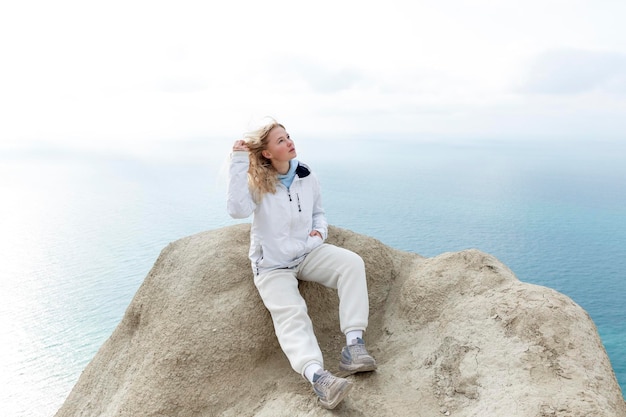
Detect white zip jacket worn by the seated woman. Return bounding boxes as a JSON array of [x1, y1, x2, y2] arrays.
[[227, 151, 328, 275]]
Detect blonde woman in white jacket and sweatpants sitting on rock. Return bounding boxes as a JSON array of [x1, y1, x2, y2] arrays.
[[227, 121, 376, 409]]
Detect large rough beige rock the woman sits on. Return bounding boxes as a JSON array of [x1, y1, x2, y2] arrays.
[[57, 224, 626, 417]]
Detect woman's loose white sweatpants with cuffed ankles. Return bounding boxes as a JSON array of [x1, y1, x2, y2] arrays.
[[254, 244, 369, 375]]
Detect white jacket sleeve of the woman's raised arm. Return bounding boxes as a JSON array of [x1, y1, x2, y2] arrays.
[[226, 151, 256, 219]]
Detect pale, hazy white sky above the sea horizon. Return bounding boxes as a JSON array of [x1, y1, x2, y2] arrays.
[[0, 0, 626, 152]]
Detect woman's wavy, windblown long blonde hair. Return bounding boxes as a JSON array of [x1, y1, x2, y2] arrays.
[[245, 119, 285, 203]]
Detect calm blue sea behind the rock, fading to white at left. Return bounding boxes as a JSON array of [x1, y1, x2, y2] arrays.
[[0, 132, 626, 417]]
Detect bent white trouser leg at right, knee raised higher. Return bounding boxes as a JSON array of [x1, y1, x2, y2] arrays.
[[297, 244, 369, 334]]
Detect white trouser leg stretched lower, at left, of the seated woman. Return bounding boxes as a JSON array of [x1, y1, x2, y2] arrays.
[[254, 269, 324, 375]]
